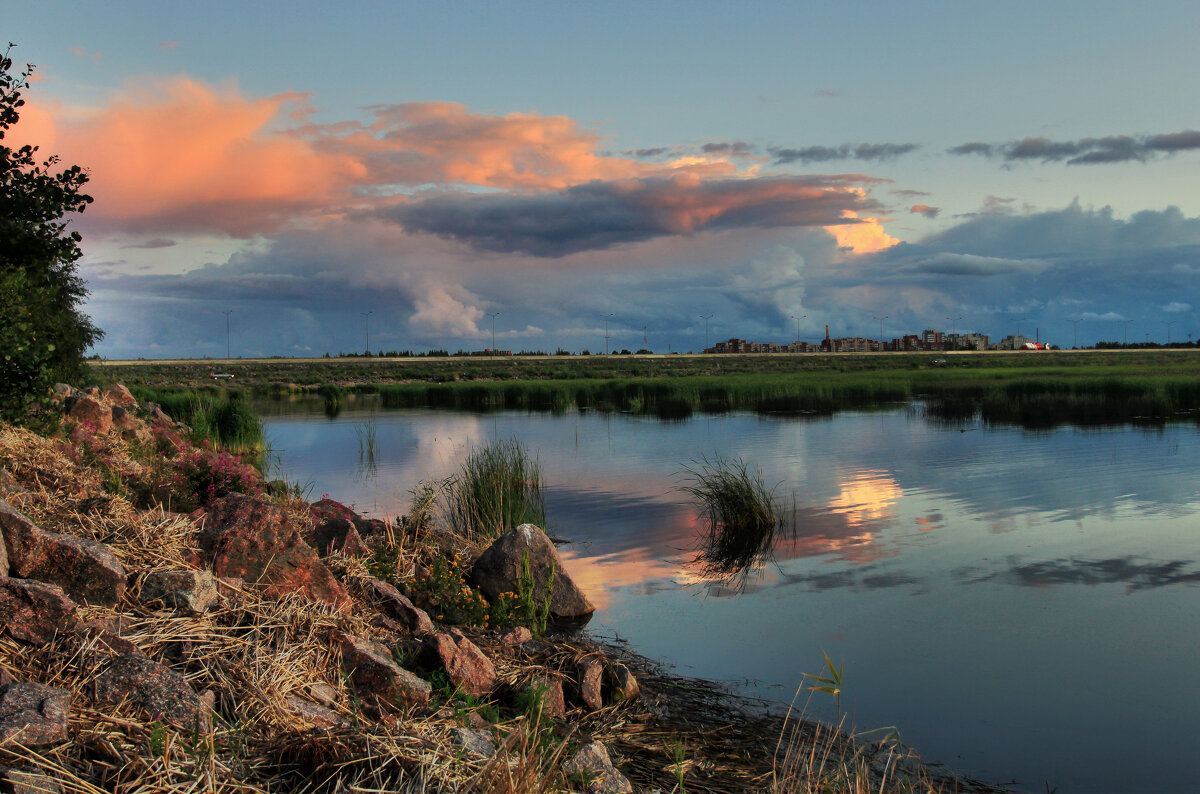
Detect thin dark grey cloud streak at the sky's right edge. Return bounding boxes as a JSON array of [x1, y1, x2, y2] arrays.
[[947, 130, 1200, 166]]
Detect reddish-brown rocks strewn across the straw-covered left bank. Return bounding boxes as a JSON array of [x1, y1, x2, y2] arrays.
[[0, 386, 638, 792]]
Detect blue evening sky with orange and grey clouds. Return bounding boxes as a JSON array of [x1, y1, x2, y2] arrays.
[[4, 0, 1200, 359]]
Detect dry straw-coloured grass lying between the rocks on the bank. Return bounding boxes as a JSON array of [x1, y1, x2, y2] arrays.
[[0, 426, 1012, 794]]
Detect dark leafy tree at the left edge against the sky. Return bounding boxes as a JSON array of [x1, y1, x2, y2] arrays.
[[0, 43, 103, 422]]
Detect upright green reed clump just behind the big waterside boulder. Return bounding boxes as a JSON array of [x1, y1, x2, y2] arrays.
[[442, 439, 546, 541]]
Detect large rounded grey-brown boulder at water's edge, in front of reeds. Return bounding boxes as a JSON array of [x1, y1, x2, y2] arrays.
[[470, 524, 595, 619]]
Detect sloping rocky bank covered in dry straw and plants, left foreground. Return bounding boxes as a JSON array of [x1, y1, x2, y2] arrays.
[[0, 383, 1012, 792]]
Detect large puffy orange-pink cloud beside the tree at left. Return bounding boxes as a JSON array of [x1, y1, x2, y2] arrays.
[[17, 78, 366, 236]]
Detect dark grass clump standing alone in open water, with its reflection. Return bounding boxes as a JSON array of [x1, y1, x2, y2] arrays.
[[682, 458, 794, 584]]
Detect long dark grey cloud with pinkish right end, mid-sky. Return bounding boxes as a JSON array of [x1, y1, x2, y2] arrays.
[[379, 176, 877, 257]]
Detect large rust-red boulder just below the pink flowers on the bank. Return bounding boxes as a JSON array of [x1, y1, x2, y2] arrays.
[[200, 494, 352, 610]]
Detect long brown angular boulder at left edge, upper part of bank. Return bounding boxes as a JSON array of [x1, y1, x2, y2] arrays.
[[0, 499, 125, 607]]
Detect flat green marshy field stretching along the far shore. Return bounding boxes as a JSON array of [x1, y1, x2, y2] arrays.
[[91, 349, 1200, 426]]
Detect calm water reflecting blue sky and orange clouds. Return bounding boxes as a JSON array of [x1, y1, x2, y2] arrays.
[[268, 409, 1200, 793]]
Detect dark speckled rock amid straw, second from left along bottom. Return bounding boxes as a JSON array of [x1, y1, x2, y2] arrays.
[[95, 654, 212, 733]]
